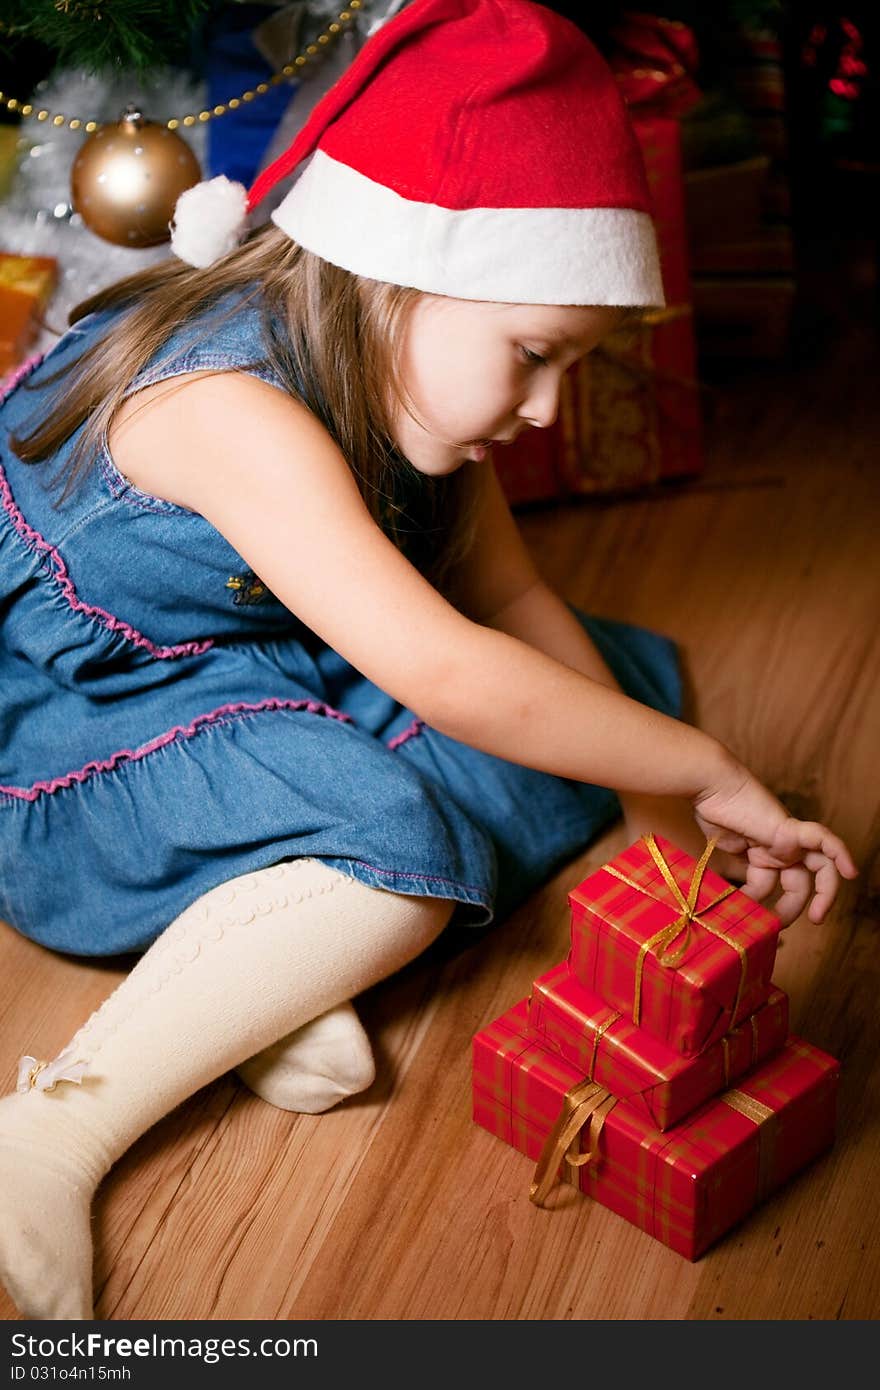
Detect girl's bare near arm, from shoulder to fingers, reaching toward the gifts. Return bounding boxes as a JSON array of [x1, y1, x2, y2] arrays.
[[115, 373, 856, 910]]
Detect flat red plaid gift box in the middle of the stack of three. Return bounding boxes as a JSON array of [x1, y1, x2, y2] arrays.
[[528, 962, 788, 1130]]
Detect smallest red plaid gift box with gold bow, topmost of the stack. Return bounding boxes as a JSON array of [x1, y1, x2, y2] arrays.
[[569, 835, 781, 1056]]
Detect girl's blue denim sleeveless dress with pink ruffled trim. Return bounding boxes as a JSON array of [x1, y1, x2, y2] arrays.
[[0, 282, 681, 955]]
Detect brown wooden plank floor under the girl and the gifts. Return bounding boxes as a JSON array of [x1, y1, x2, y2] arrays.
[[0, 241, 880, 1321]]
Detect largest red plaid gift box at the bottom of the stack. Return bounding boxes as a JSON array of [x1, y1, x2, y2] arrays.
[[473, 999, 840, 1259]]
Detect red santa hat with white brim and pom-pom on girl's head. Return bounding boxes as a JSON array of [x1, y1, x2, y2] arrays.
[[171, 0, 665, 307]]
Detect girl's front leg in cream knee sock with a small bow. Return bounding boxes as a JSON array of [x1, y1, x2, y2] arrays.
[[0, 859, 455, 1318]]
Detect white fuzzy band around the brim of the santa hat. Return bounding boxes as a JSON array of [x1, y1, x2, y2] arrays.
[[271, 150, 666, 309]]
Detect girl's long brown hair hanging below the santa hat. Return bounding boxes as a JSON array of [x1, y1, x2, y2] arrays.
[[10, 222, 478, 599]]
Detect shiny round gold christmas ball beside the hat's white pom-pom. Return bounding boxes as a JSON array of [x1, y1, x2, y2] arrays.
[[71, 106, 202, 247]]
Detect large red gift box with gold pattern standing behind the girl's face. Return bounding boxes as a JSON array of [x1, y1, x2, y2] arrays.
[[494, 115, 703, 505]]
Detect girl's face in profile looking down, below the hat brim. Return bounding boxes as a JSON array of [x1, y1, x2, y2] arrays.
[[392, 295, 627, 475]]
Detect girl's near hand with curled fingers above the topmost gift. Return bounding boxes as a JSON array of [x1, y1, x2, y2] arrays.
[[694, 763, 858, 927]]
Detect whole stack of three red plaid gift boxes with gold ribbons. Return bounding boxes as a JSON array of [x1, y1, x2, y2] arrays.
[[473, 835, 840, 1259]]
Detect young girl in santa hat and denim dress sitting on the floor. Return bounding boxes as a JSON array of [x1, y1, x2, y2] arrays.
[[0, 0, 856, 1318]]
